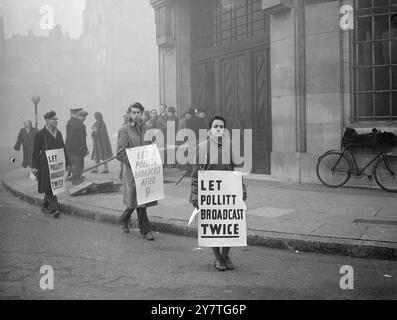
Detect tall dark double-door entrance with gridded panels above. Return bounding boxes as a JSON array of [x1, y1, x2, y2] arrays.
[[192, 0, 272, 174]]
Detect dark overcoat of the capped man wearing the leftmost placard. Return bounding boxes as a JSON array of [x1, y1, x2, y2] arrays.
[[32, 127, 69, 194]]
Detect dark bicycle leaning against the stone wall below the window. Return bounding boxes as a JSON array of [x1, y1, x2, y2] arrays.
[[316, 147, 397, 192]]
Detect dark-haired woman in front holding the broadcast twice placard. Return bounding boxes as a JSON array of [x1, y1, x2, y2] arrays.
[[190, 116, 247, 271]]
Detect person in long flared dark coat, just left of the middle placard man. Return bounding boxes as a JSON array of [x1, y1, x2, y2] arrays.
[[91, 112, 113, 173]]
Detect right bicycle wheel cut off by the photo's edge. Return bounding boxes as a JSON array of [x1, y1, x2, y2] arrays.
[[374, 155, 397, 192]]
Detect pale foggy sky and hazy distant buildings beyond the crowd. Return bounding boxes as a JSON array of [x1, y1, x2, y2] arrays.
[[0, 0, 159, 160]]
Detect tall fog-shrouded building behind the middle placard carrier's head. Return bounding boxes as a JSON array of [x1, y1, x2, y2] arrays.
[[80, 0, 158, 109]]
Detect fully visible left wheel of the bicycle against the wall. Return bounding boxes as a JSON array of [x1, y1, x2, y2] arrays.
[[316, 151, 352, 188]]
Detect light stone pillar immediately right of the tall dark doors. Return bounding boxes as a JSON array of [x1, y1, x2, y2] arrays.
[[262, 0, 306, 180]]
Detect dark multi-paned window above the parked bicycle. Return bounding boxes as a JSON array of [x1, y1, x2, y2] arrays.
[[354, 0, 397, 121]]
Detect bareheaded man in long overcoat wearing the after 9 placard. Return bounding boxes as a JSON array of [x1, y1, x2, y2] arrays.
[[117, 102, 157, 241]]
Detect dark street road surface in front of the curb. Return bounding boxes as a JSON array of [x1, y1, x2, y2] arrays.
[[0, 147, 397, 300]]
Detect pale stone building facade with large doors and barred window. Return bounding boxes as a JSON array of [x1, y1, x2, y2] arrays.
[[151, 0, 397, 183]]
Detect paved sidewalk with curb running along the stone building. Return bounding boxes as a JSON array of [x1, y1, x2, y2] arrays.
[[3, 161, 397, 260]]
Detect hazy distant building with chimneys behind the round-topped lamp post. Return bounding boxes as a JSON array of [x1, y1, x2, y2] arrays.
[[0, 19, 82, 132]]
